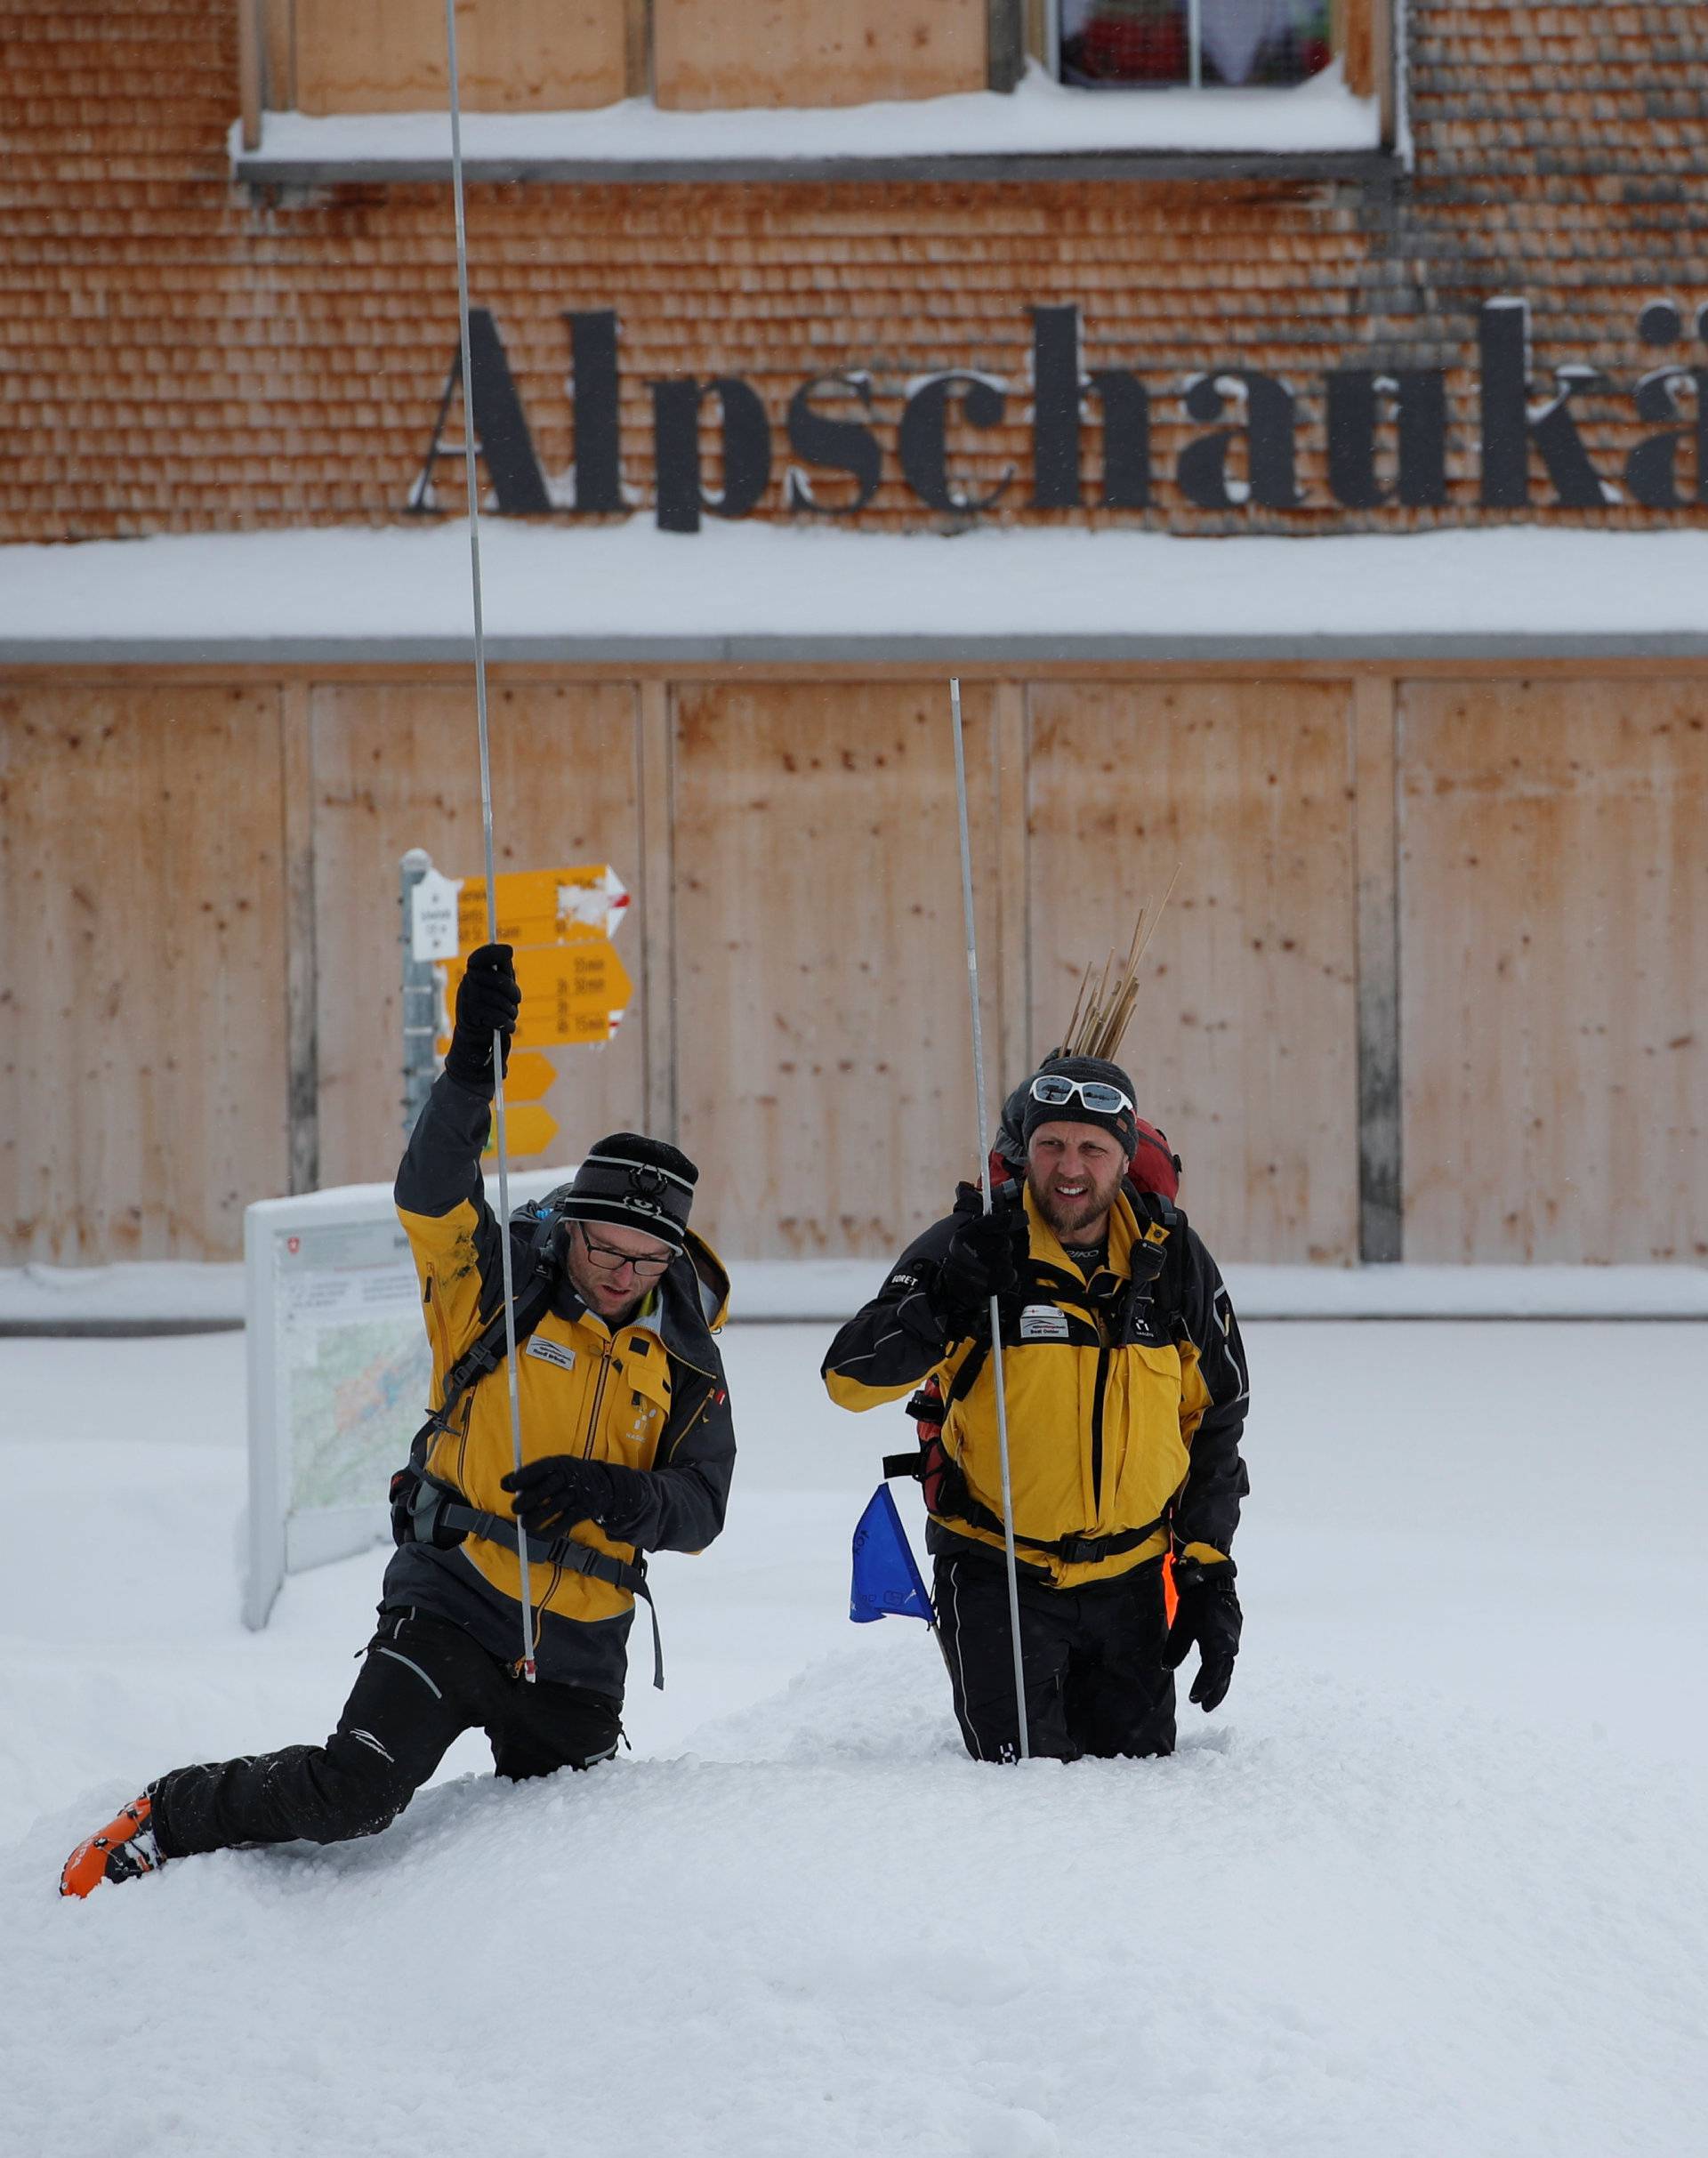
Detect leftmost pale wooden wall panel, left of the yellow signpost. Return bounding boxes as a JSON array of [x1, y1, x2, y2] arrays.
[[0, 684, 289, 1265]]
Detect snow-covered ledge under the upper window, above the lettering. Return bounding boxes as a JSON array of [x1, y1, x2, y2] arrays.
[[231, 60, 1393, 188]]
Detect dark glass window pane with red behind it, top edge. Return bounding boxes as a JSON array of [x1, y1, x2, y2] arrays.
[[1060, 0, 1334, 91]]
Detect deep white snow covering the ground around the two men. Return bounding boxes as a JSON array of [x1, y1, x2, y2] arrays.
[[0, 1323, 1708, 2158]]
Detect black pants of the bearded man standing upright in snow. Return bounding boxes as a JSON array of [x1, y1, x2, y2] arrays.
[[935, 1550, 1174, 1761]]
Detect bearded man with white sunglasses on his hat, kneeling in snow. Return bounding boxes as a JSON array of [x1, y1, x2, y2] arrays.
[[825, 1058, 1246, 1761]]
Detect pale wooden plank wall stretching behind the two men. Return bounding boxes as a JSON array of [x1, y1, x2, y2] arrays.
[[0, 669, 1708, 1265]]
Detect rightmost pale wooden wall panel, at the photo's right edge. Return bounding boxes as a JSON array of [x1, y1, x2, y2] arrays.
[[1399, 680, 1708, 1260]]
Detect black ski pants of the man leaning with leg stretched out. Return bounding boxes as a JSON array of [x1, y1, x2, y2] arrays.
[[149, 1606, 622, 1858]]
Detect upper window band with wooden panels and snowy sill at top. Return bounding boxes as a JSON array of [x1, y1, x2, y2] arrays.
[[233, 0, 1399, 173]]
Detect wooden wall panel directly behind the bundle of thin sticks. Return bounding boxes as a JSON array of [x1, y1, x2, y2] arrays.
[[1015, 682, 1358, 1260]]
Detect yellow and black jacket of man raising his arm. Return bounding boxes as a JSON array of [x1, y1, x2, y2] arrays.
[[384, 1075, 737, 1698]]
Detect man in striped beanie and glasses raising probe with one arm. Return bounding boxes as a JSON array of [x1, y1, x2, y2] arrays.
[[60, 946, 734, 1895]]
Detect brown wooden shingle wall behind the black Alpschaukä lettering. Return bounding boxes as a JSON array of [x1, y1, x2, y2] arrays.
[[0, 0, 1708, 540]]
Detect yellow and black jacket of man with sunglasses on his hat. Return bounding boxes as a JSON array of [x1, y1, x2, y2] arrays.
[[825, 1185, 1248, 1589]]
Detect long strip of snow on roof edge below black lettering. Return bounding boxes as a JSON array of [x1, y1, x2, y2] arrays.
[[0, 516, 1708, 642]]
